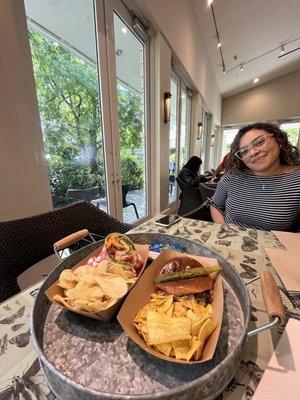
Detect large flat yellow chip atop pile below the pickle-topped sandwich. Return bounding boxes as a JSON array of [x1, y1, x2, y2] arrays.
[[145, 311, 191, 345]]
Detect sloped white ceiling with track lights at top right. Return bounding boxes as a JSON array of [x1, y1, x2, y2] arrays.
[[190, 0, 300, 98]]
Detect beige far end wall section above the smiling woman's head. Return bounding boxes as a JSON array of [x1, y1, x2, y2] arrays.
[[222, 71, 300, 125]]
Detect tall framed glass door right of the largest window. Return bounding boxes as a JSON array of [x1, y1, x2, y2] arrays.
[[105, 1, 151, 223]]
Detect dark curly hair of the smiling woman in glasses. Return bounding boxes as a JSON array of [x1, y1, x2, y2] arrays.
[[226, 122, 299, 171]]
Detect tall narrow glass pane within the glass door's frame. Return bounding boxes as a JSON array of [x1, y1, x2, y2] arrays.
[[114, 13, 147, 222]]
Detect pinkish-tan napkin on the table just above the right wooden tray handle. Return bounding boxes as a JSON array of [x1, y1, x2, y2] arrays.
[[266, 249, 300, 294]]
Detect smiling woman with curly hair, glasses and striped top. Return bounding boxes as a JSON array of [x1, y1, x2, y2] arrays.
[[211, 123, 300, 231]]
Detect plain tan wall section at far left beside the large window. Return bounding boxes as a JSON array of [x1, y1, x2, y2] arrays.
[[0, 0, 52, 221]]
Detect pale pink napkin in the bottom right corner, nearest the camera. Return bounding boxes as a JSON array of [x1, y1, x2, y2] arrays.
[[252, 318, 300, 400]]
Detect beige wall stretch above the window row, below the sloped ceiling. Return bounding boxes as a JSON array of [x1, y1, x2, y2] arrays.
[[138, 0, 222, 122]]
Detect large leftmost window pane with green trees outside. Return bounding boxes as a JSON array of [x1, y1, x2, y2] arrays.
[[25, 0, 106, 209]]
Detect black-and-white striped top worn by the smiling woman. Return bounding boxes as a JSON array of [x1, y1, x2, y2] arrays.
[[212, 169, 300, 231]]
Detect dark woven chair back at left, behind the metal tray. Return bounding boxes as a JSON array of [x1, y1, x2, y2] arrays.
[[0, 201, 132, 302]]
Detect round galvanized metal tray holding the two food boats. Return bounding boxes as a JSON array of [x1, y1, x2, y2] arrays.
[[31, 233, 250, 400]]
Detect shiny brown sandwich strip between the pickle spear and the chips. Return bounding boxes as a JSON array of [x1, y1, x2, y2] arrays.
[[155, 275, 213, 296]]
